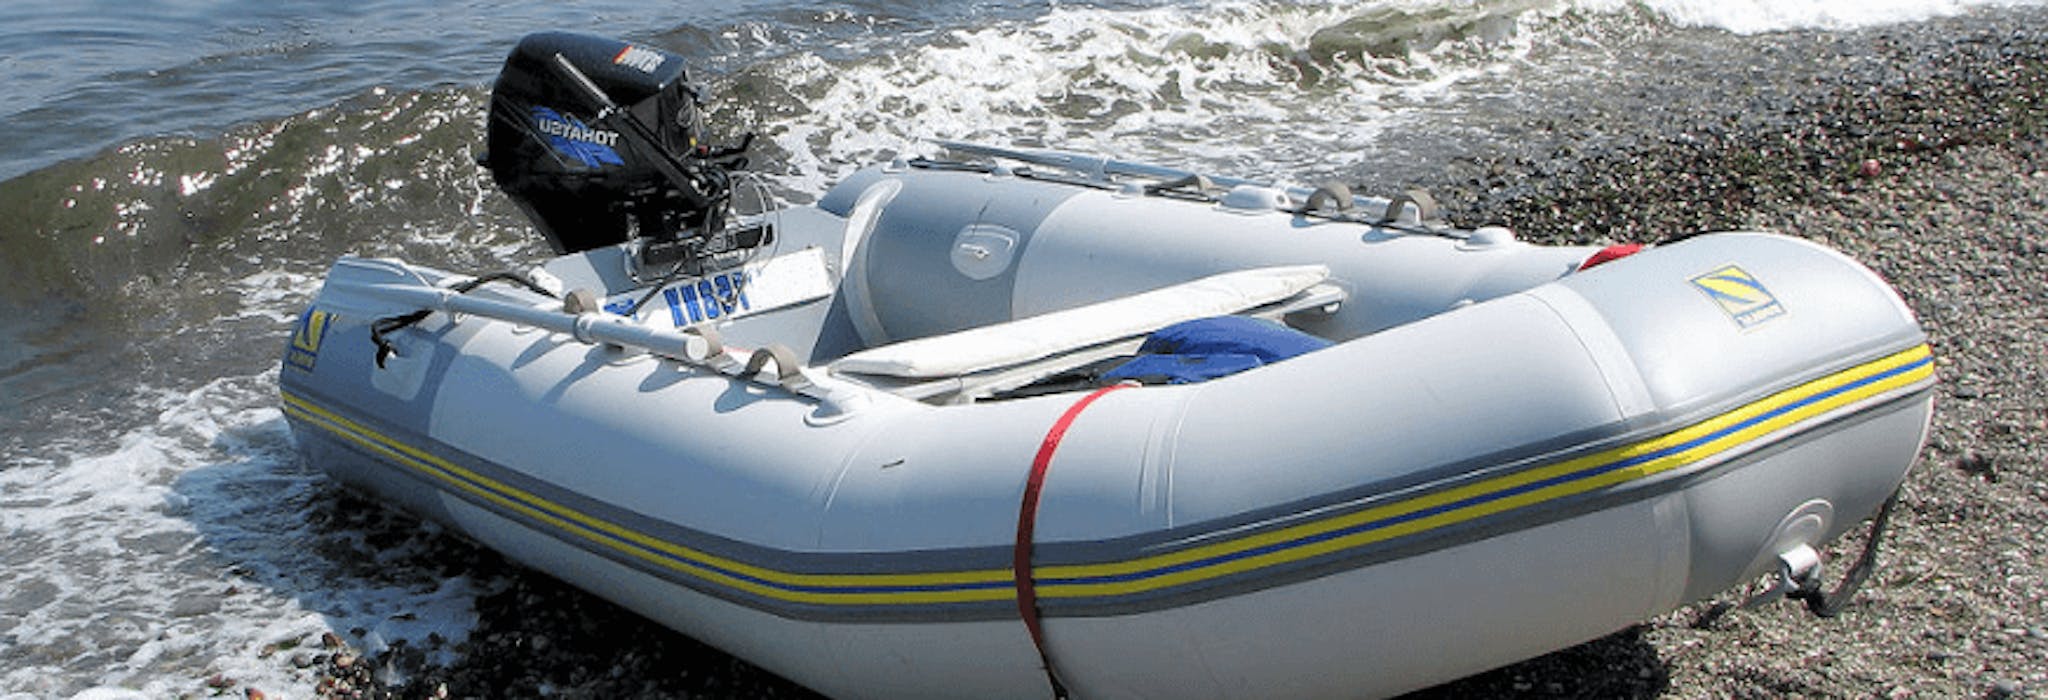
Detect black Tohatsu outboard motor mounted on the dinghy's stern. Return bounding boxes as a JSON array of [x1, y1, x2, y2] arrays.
[[483, 33, 764, 272]]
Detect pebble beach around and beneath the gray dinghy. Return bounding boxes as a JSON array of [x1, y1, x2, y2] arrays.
[[292, 8, 2048, 698]]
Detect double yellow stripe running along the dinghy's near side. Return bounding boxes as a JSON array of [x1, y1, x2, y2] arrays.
[[283, 344, 1933, 606]]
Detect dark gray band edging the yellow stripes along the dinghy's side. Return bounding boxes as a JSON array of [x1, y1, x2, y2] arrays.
[[280, 352, 1927, 622]]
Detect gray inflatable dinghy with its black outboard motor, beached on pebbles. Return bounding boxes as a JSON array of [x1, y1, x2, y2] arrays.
[[281, 35, 1933, 698]]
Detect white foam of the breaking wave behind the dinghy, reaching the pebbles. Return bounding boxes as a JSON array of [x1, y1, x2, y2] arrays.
[[762, 0, 2044, 192]]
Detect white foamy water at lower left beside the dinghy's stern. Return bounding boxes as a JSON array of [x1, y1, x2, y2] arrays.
[[0, 370, 479, 700]]
